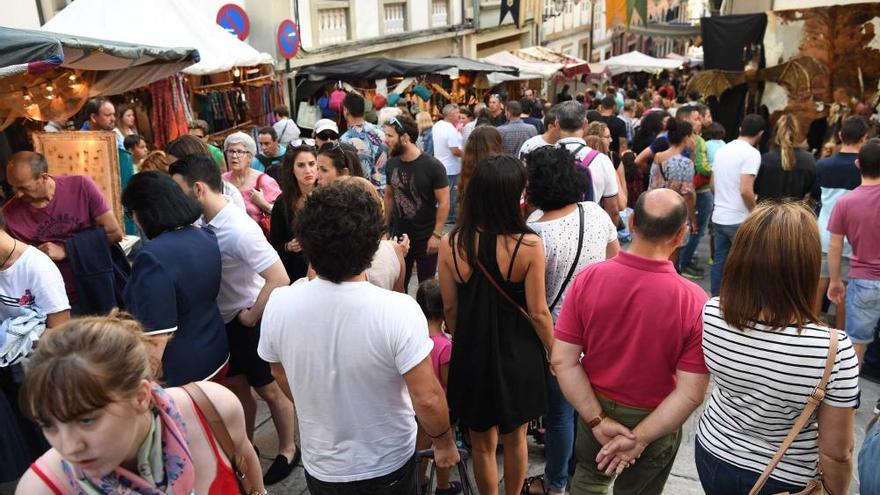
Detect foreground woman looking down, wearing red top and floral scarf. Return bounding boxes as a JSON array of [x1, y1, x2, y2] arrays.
[[16, 315, 267, 495]]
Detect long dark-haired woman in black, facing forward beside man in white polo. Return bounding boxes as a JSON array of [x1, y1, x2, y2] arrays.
[[269, 146, 318, 281]]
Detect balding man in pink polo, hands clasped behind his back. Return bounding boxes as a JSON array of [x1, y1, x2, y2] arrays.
[[552, 189, 709, 494]]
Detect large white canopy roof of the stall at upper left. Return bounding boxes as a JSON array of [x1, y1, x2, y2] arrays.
[[41, 0, 274, 75]]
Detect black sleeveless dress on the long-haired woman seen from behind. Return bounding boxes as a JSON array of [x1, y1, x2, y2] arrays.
[[447, 234, 548, 433]]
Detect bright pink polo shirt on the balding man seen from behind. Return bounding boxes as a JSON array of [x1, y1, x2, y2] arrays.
[[555, 251, 709, 408]]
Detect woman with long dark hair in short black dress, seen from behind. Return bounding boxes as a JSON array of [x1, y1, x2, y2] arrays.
[[439, 155, 553, 495]]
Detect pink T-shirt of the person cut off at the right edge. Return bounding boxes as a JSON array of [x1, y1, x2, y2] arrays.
[[828, 185, 880, 280]]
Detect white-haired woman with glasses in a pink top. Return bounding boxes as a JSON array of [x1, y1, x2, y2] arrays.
[[223, 132, 281, 223]]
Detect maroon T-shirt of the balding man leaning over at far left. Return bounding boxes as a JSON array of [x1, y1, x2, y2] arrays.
[[3, 175, 110, 302]]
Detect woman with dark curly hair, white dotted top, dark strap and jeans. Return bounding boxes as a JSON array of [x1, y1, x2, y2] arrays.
[[526, 145, 620, 495]]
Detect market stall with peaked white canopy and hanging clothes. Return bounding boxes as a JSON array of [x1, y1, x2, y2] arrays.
[[42, 0, 283, 147]]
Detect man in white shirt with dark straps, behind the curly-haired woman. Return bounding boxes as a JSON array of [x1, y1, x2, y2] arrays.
[[553, 101, 620, 225]]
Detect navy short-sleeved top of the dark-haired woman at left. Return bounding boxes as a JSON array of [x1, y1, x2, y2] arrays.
[[125, 227, 229, 387]]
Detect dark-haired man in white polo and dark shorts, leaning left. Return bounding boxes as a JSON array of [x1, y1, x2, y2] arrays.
[[168, 155, 298, 484]]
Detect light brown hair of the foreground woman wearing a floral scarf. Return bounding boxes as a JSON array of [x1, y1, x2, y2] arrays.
[[19, 312, 161, 424]]
